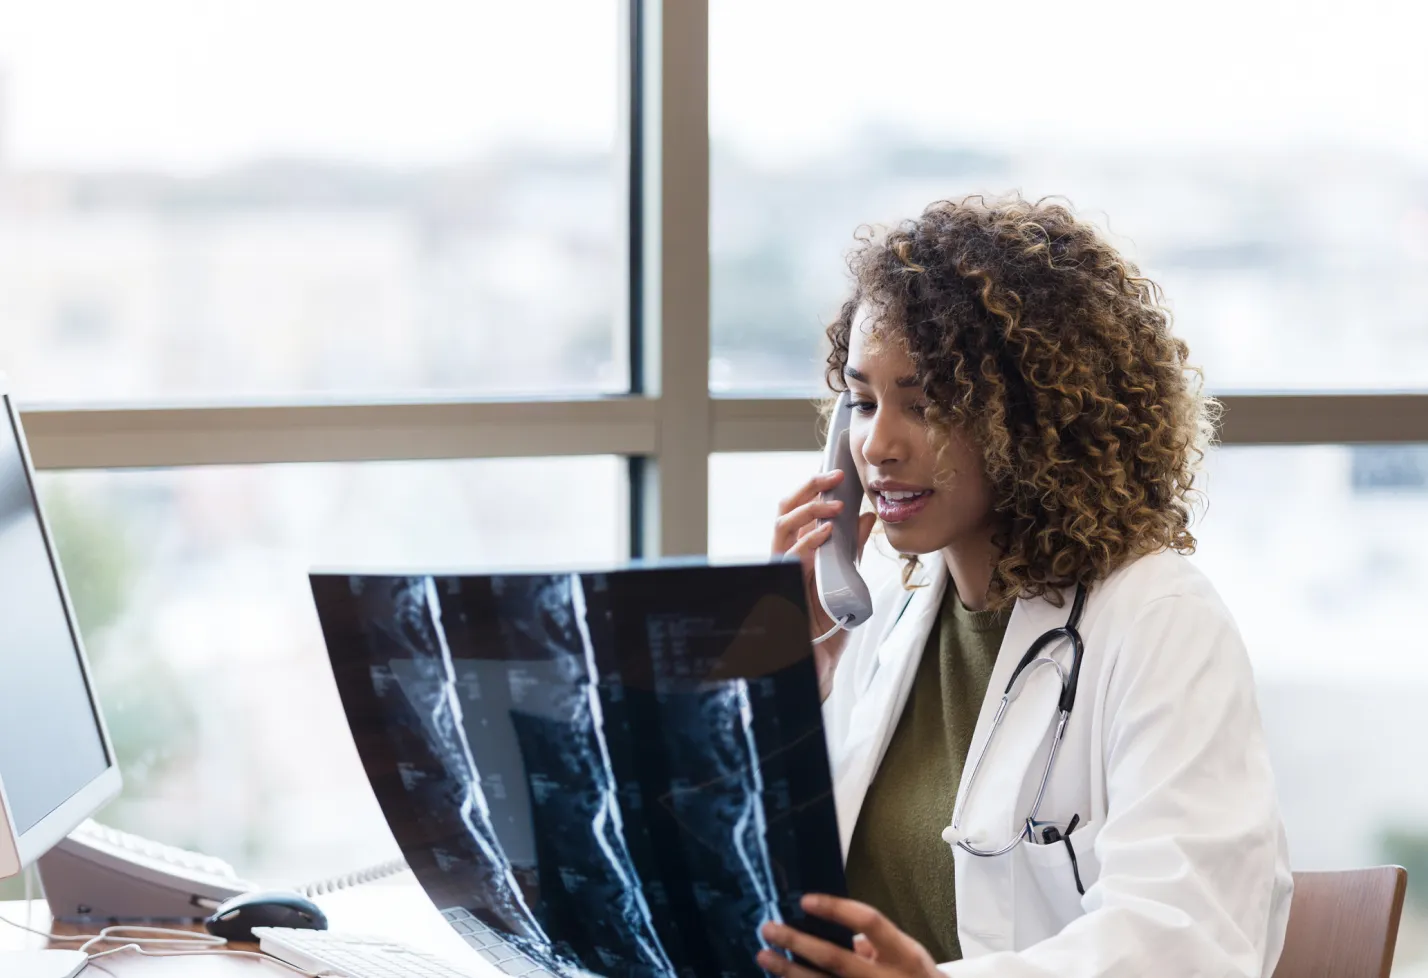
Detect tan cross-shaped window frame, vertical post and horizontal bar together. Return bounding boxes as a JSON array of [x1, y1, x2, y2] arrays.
[[21, 0, 1428, 557]]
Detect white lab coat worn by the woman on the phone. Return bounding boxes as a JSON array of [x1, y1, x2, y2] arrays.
[[824, 540, 1292, 978]]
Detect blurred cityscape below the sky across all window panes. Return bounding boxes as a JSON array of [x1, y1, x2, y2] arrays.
[[0, 43, 1428, 974]]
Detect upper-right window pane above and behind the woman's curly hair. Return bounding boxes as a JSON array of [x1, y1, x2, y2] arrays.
[[710, 0, 1428, 393]]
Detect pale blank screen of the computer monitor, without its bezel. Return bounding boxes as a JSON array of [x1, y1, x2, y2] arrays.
[[0, 395, 110, 834]]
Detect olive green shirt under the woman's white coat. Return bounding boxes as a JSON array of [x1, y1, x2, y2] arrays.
[[847, 583, 1011, 962]]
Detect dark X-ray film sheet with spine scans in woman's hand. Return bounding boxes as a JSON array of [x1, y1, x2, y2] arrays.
[[313, 564, 850, 978]]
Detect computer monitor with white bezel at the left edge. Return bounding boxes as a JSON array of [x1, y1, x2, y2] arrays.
[[0, 375, 120, 879]]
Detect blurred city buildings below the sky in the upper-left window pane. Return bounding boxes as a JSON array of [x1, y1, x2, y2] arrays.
[[0, 134, 627, 403]]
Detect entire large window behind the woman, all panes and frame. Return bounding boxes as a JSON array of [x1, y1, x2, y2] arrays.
[[0, 0, 1428, 967]]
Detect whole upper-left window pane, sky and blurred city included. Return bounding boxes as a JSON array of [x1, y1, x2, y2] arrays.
[[0, 0, 628, 403]]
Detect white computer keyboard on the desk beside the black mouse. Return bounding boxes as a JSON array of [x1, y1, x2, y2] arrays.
[[253, 927, 488, 978]]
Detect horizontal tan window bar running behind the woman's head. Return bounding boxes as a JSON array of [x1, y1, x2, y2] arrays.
[[21, 388, 1428, 468]]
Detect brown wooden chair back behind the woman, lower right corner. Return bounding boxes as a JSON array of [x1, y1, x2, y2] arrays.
[[1274, 867, 1408, 978]]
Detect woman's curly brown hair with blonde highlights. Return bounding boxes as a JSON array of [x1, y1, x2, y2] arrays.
[[827, 196, 1218, 607]]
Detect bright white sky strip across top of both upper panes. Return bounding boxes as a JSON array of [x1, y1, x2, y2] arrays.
[[0, 0, 1428, 168]]
